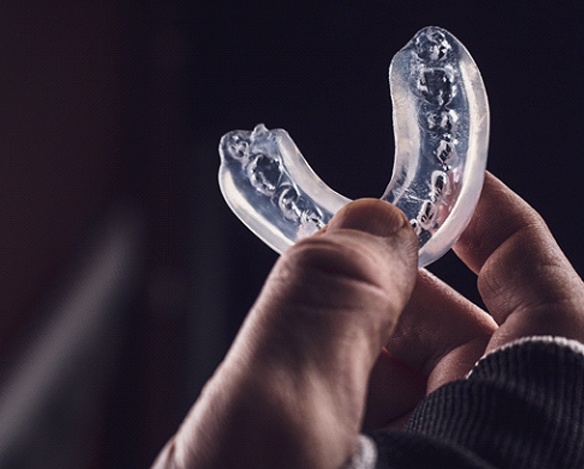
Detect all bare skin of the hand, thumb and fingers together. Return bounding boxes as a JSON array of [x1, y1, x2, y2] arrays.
[[155, 174, 584, 468]]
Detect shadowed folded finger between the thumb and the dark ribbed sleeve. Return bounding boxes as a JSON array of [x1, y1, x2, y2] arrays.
[[365, 269, 497, 428]]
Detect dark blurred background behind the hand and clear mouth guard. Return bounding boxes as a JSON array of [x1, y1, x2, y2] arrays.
[[0, 0, 584, 468]]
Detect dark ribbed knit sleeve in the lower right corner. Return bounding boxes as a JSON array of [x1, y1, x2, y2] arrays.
[[369, 339, 584, 468]]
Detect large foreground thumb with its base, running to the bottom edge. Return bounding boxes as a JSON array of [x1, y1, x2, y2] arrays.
[[156, 200, 418, 468]]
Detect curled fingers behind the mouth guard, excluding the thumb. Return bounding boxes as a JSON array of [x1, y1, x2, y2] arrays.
[[365, 174, 584, 428]]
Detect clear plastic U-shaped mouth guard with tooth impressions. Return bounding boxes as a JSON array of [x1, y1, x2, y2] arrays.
[[219, 26, 489, 267]]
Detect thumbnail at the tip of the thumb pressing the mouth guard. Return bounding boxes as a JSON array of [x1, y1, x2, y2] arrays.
[[326, 199, 409, 237]]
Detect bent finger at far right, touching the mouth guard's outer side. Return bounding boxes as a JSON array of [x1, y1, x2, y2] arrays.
[[454, 174, 584, 347]]
